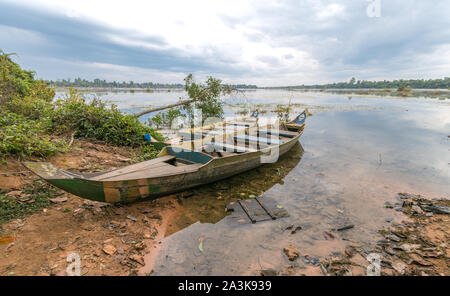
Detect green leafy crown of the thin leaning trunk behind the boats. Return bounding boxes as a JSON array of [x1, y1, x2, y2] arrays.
[[182, 74, 233, 125]]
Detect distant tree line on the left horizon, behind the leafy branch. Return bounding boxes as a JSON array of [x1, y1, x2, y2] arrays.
[[47, 78, 257, 89]]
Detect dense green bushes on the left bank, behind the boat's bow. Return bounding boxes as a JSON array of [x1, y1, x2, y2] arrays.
[[0, 51, 164, 156]]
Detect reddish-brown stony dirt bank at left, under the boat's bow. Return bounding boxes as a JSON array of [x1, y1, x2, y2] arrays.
[[0, 141, 177, 275]]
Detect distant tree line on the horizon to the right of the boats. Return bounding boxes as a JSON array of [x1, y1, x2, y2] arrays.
[[289, 77, 450, 89]]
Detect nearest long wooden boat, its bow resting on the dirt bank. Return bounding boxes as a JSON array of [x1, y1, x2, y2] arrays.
[[23, 112, 306, 203]]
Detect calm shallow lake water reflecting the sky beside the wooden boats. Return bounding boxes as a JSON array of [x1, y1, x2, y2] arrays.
[[57, 90, 450, 275]]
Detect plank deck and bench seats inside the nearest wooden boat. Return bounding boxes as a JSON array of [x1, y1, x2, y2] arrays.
[[89, 121, 298, 182]]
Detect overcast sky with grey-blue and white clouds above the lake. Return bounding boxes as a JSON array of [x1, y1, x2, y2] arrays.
[[0, 0, 450, 86]]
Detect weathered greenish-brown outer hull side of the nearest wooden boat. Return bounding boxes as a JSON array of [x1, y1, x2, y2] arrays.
[[24, 124, 304, 203]]
